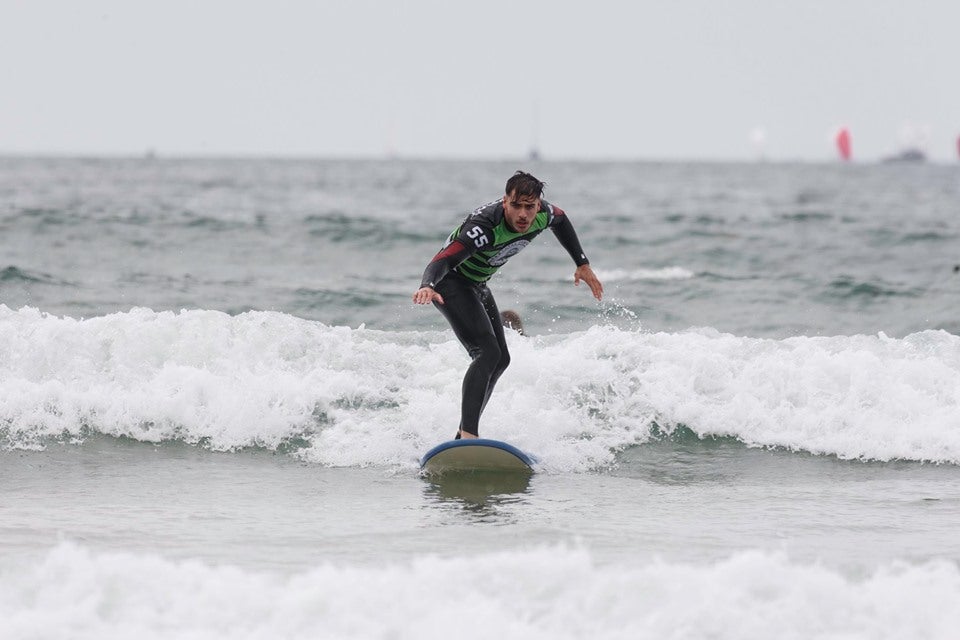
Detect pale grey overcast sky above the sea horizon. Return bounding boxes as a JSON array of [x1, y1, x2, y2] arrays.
[[0, 0, 960, 162]]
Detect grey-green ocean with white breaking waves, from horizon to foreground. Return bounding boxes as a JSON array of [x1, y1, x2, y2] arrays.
[[0, 158, 960, 640]]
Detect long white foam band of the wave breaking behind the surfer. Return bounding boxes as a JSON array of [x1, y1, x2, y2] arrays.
[[0, 306, 960, 471]]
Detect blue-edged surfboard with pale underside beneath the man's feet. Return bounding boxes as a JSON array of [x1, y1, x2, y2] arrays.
[[420, 438, 536, 475]]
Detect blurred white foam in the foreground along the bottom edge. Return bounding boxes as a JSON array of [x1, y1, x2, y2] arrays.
[[0, 543, 960, 640]]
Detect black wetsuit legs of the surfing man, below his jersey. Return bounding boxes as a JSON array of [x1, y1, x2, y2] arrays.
[[434, 273, 510, 435]]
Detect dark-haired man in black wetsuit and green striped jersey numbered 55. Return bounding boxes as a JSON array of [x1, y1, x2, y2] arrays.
[[413, 171, 603, 439]]
